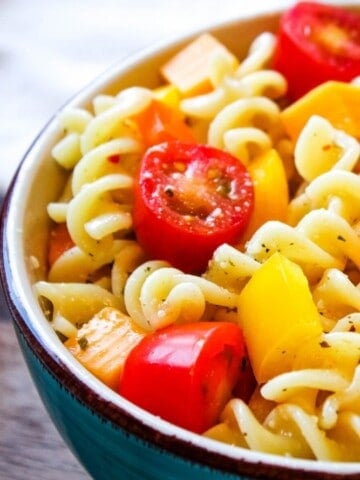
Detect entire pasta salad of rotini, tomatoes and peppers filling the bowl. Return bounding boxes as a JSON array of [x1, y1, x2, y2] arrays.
[[34, 2, 360, 461]]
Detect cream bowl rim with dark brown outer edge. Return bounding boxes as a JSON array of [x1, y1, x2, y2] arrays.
[[0, 1, 360, 479]]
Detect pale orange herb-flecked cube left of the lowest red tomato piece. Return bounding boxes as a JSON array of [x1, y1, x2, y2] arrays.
[[65, 307, 146, 390]]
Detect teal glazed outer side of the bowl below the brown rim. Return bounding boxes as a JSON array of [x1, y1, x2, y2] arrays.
[[12, 327, 246, 480]]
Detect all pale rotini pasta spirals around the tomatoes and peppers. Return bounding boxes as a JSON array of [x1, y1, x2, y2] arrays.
[[35, 15, 360, 461]]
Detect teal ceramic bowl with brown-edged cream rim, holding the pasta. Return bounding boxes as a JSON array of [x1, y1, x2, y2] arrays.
[[1, 1, 360, 480]]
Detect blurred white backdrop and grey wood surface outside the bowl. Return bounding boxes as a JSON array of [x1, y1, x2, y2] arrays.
[[0, 0, 293, 480]]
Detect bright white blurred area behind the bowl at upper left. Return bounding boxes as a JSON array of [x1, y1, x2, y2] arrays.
[[0, 0, 293, 192]]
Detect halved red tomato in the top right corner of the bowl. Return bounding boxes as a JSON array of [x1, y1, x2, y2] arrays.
[[273, 2, 360, 100]]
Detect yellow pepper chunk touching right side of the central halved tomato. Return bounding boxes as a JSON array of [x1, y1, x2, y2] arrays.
[[241, 149, 289, 248]]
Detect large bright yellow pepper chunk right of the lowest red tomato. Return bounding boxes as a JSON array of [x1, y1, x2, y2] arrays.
[[238, 253, 322, 383]]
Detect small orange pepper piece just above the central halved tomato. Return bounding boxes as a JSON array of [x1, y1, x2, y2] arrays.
[[134, 99, 195, 147]]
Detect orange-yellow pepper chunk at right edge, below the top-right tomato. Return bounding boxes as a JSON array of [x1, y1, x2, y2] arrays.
[[281, 81, 360, 142]]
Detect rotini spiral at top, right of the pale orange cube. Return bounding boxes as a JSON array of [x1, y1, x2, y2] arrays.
[[181, 33, 289, 164]]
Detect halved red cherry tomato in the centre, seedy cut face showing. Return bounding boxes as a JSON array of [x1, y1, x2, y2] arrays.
[[133, 142, 254, 273]]
